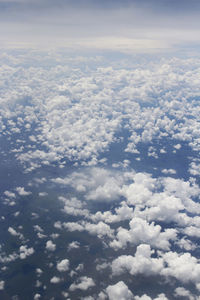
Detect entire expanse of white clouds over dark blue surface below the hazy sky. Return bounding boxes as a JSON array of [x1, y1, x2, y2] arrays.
[[0, 51, 200, 300]]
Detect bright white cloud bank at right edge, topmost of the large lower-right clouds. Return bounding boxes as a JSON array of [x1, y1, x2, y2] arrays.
[[123, 173, 200, 216]]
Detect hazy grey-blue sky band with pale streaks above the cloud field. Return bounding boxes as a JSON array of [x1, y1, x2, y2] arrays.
[[0, 0, 200, 53]]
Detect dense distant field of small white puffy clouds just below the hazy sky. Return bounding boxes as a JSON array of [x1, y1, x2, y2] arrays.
[[0, 53, 200, 171]]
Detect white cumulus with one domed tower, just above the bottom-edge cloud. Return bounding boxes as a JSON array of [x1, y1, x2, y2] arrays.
[[111, 244, 164, 276]]
